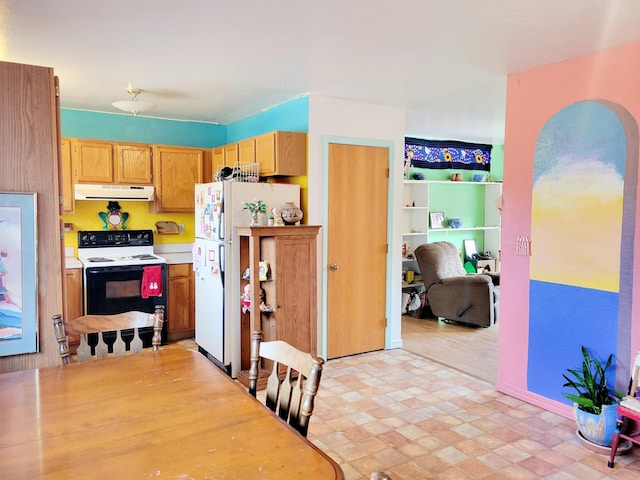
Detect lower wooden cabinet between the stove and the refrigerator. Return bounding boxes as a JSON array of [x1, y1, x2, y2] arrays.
[[167, 263, 196, 341]]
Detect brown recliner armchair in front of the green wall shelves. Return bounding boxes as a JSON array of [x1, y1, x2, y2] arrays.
[[415, 242, 500, 327]]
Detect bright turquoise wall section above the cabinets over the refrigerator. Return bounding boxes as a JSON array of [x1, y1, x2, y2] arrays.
[[226, 97, 309, 143]]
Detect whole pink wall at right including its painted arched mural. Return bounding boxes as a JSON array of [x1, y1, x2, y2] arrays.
[[496, 42, 640, 417]]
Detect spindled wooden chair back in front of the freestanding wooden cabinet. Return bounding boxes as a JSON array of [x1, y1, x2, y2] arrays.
[[249, 332, 324, 437]]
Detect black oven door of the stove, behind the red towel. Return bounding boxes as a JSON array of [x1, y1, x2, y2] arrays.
[[84, 264, 168, 343]]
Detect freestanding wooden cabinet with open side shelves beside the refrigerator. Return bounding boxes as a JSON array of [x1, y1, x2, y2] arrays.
[[237, 225, 320, 381]]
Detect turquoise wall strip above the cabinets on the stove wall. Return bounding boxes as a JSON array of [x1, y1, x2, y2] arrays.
[[60, 108, 227, 148]]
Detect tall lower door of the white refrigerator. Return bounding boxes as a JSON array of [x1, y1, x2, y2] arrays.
[[196, 239, 229, 365]]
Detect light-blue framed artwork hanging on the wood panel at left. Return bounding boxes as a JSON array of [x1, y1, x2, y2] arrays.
[[0, 193, 38, 356]]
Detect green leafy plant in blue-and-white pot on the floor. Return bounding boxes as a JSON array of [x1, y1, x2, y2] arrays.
[[562, 346, 624, 447]]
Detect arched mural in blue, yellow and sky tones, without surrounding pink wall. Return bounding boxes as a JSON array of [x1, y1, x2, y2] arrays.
[[528, 101, 633, 401]]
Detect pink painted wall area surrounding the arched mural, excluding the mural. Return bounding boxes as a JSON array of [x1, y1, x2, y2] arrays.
[[497, 43, 640, 416]]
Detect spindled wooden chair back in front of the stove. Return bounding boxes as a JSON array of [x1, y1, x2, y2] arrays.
[[53, 305, 164, 365]]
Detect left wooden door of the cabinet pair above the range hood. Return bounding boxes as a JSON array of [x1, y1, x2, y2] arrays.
[[72, 139, 114, 184]]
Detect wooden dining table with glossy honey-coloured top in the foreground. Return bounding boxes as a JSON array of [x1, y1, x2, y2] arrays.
[[0, 348, 344, 480]]
